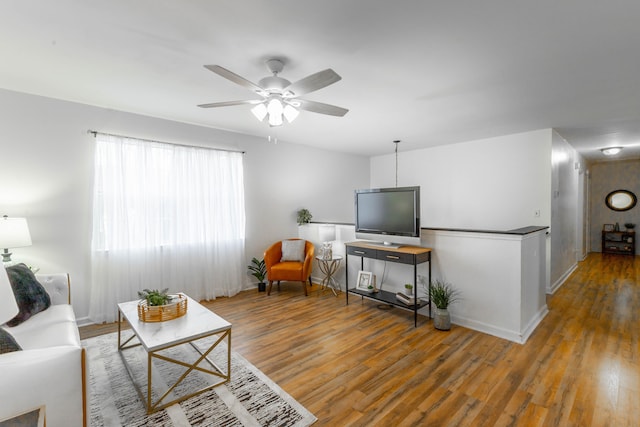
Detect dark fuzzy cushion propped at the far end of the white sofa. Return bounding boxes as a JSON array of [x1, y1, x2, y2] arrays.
[[7, 264, 51, 326]]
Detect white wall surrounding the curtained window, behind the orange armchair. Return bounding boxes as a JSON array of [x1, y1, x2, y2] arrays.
[[0, 90, 369, 319]]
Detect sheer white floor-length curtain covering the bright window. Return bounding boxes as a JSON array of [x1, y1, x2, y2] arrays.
[[89, 133, 246, 322]]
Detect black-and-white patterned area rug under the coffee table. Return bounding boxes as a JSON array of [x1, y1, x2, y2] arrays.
[[82, 331, 317, 427]]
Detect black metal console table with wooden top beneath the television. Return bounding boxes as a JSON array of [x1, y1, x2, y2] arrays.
[[345, 242, 431, 327]]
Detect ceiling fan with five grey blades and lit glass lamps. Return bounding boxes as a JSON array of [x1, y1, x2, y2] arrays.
[[198, 58, 349, 126]]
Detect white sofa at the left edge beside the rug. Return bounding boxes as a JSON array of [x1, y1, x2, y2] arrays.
[[0, 268, 88, 427]]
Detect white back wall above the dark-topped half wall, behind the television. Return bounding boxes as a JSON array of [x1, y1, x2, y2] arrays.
[[371, 129, 551, 230]]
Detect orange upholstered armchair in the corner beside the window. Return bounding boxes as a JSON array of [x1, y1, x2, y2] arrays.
[[264, 239, 315, 296]]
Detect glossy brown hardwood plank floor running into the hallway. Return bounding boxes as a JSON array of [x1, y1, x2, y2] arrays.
[[81, 253, 640, 426]]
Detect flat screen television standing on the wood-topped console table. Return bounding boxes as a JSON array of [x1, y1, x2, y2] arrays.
[[355, 187, 420, 247]]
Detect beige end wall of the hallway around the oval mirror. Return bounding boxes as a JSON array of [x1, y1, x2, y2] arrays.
[[589, 160, 640, 255]]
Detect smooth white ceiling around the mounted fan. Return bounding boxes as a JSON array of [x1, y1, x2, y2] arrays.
[[0, 0, 640, 160]]
